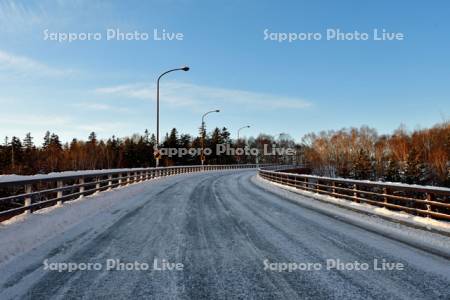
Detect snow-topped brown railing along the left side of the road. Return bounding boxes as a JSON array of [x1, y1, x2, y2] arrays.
[[0, 164, 261, 221]]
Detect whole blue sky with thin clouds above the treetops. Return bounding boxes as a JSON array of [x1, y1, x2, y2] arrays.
[[0, 0, 450, 142]]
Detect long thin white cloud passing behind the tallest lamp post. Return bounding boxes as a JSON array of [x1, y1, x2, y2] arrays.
[[94, 81, 312, 110]]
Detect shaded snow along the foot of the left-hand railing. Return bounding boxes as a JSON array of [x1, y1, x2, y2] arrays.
[[0, 174, 171, 265]]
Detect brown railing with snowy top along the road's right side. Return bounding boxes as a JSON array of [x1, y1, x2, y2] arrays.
[[258, 168, 450, 220]]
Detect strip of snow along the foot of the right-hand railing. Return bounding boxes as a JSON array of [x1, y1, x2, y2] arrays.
[[252, 176, 450, 258]]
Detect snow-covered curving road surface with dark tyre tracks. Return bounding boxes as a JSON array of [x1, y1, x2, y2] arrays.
[[0, 171, 450, 299]]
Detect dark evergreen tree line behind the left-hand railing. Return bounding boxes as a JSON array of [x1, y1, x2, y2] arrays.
[[0, 128, 288, 175]]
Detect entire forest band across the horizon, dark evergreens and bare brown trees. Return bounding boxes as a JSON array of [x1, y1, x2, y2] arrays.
[[0, 122, 450, 186]]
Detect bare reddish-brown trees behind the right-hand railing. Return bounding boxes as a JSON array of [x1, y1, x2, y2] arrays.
[[302, 122, 450, 186]]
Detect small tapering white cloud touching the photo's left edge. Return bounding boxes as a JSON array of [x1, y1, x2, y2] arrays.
[[0, 50, 73, 77]]
